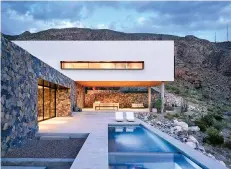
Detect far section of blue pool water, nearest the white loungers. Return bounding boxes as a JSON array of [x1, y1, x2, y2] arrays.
[[108, 126, 177, 152]]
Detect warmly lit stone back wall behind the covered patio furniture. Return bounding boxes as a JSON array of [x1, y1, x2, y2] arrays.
[[85, 90, 155, 108]]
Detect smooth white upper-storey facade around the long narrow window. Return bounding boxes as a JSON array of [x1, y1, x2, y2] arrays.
[[13, 41, 174, 81]]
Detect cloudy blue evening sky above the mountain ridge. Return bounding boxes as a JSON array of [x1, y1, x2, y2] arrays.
[[2, 1, 231, 41]]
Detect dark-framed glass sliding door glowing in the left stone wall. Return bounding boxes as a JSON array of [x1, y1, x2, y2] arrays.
[[38, 80, 56, 121]]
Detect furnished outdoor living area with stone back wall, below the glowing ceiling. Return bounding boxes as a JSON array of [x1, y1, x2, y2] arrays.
[[77, 85, 160, 112]]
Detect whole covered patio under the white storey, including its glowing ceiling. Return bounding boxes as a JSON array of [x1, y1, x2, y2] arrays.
[[76, 81, 165, 112]]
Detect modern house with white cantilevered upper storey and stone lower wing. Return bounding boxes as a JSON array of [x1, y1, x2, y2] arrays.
[[1, 38, 174, 153]]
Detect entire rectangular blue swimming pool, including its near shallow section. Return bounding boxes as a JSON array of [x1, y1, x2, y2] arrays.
[[108, 125, 202, 169]]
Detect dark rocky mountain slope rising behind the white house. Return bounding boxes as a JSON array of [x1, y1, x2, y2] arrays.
[[1, 28, 231, 111]]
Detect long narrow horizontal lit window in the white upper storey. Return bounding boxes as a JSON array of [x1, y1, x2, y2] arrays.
[[61, 61, 144, 70]]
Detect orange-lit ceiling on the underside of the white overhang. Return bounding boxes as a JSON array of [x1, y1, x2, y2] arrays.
[[77, 81, 161, 87]]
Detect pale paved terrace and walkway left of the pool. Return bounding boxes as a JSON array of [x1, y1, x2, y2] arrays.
[[39, 112, 138, 169]]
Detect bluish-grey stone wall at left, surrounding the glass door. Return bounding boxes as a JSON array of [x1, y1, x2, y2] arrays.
[[1, 37, 76, 155]]
